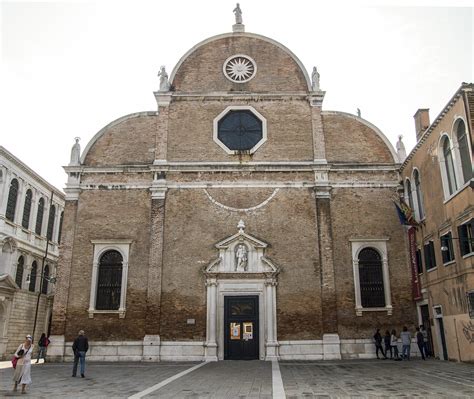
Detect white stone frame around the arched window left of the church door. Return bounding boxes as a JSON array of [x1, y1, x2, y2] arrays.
[[87, 239, 133, 319]]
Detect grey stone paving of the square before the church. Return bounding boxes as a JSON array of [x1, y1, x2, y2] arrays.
[[0, 360, 474, 399]]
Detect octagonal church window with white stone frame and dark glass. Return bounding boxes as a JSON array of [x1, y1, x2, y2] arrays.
[[214, 106, 266, 154]]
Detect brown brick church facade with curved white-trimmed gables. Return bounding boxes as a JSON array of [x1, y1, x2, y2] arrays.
[[48, 15, 416, 361]]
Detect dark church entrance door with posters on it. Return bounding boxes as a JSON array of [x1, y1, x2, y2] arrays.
[[224, 296, 259, 360]]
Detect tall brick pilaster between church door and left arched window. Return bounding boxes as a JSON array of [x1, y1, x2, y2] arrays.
[[143, 177, 167, 361]]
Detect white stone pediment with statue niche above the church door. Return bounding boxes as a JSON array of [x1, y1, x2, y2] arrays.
[[204, 220, 280, 276]]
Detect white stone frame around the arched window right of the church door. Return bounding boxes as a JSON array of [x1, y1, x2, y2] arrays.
[[349, 237, 393, 316]]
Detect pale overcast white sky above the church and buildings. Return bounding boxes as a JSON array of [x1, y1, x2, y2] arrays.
[[0, 0, 474, 189]]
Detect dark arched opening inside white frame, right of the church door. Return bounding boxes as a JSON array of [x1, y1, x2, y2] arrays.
[[359, 248, 385, 308]]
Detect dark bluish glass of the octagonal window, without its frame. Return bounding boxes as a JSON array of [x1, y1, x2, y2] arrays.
[[217, 110, 263, 151]]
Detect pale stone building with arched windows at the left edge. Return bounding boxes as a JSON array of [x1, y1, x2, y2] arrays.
[[0, 146, 64, 359]]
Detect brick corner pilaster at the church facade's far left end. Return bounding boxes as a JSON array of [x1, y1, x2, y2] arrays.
[[48, 198, 78, 361]]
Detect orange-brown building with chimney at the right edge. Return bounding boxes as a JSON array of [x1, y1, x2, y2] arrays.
[[401, 83, 474, 361]]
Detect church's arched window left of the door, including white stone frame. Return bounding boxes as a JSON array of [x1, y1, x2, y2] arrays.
[[88, 240, 132, 318]]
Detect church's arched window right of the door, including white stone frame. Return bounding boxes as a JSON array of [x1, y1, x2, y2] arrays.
[[350, 238, 392, 316]]
